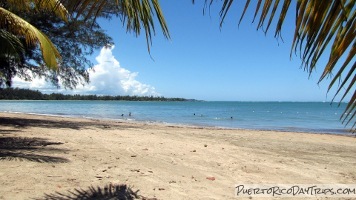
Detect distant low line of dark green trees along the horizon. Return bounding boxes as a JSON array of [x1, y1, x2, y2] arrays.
[[0, 88, 192, 101]]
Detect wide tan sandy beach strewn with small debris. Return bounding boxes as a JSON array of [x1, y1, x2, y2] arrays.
[[0, 113, 356, 199]]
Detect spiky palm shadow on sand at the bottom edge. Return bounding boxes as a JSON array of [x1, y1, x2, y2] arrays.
[[37, 184, 150, 200]]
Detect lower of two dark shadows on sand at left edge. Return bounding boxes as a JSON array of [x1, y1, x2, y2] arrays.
[[0, 137, 69, 163]]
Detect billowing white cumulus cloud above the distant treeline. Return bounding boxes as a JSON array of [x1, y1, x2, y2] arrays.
[[13, 46, 159, 96]]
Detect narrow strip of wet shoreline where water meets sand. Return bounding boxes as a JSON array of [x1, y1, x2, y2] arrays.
[[0, 111, 350, 137]]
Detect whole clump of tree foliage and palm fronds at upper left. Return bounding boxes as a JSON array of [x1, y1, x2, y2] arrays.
[[0, 0, 169, 88]]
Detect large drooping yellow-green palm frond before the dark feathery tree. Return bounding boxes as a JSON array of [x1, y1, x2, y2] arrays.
[[0, 7, 61, 70]]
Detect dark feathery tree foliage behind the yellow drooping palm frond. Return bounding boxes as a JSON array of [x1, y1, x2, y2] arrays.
[[0, 1, 116, 89]]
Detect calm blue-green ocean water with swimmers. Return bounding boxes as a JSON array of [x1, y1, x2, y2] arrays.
[[0, 101, 349, 134]]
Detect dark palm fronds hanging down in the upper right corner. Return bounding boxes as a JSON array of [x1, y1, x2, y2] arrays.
[[193, 0, 356, 132]]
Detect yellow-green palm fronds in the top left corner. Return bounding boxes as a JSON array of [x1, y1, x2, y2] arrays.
[[0, 0, 67, 84]]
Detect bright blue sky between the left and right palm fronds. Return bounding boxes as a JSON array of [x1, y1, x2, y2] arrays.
[[13, 0, 348, 101]]
